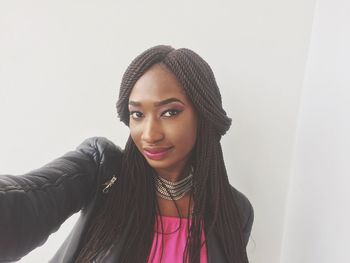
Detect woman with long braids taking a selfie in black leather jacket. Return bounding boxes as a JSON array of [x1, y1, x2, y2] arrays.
[[0, 46, 253, 262]]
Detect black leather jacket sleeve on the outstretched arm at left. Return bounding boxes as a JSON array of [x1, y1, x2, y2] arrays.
[[0, 137, 117, 262]]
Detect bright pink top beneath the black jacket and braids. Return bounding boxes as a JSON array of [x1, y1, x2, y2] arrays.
[[148, 216, 207, 263]]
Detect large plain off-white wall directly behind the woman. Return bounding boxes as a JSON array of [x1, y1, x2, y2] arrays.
[[0, 0, 314, 263]]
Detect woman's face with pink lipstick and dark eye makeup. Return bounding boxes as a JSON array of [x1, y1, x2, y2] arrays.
[[129, 64, 197, 177]]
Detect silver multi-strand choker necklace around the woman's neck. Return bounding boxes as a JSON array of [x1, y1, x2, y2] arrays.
[[154, 169, 193, 200]]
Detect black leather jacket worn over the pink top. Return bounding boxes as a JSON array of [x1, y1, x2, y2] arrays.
[[0, 137, 253, 263]]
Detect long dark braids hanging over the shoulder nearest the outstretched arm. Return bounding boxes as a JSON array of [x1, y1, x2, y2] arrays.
[[76, 137, 155, 263]]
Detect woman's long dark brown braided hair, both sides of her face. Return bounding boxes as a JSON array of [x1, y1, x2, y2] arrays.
[[77, 45, 248, 263]]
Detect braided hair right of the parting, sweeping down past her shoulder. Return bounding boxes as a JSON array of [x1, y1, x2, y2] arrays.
[[162, 49, 246, 262]]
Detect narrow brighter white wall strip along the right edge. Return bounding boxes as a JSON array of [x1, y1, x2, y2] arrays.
[[281, 0, 350, 263]]
